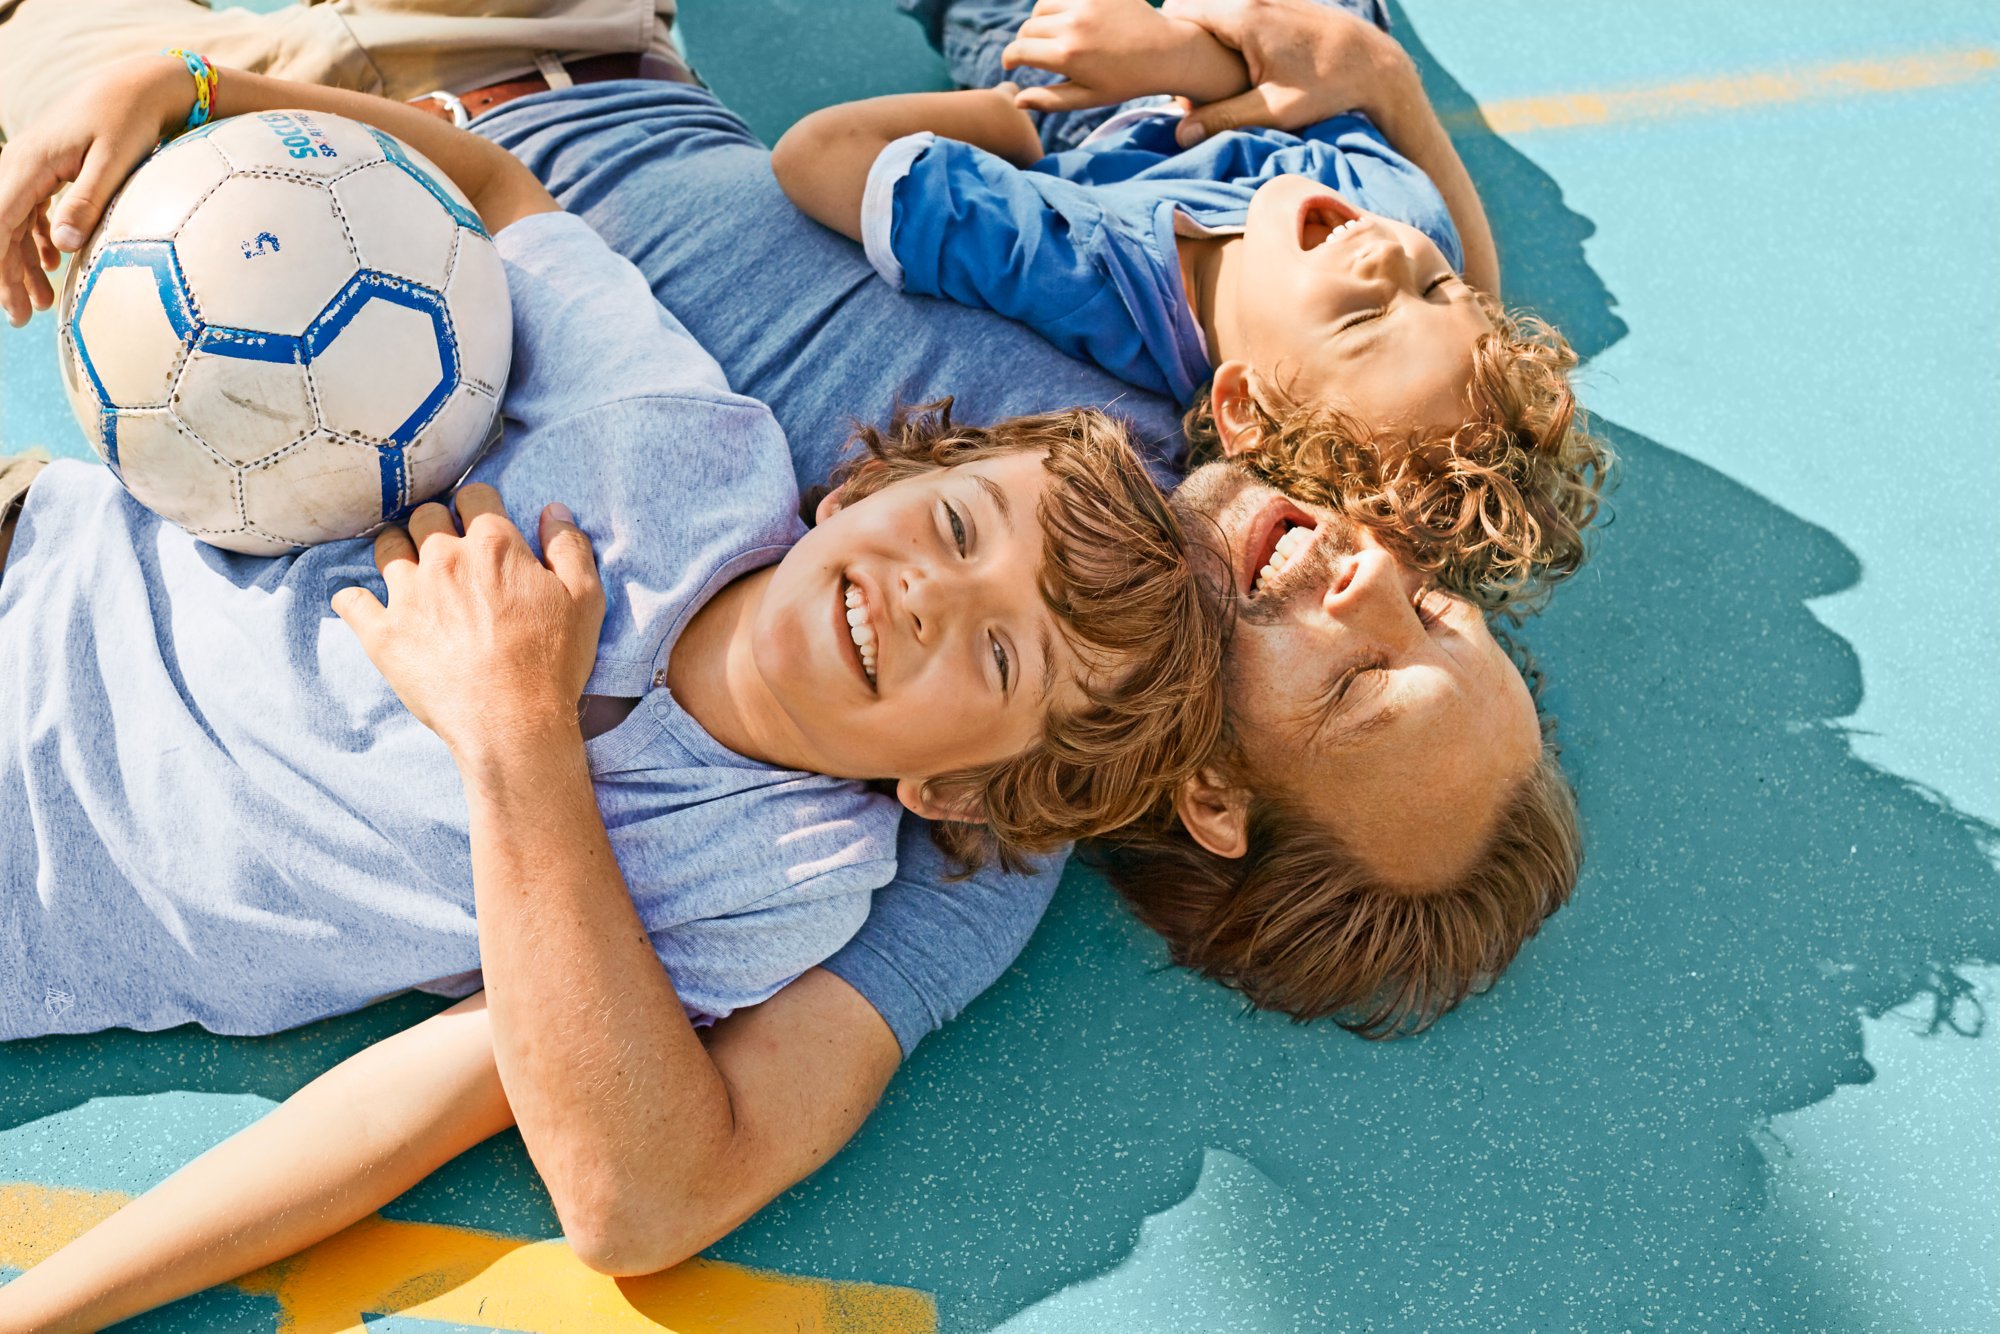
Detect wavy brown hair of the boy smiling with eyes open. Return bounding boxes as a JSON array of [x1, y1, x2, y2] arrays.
[[832, 398, 1224, 874]]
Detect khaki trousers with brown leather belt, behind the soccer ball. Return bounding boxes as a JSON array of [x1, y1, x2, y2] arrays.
[[0, 0, 680, 138]]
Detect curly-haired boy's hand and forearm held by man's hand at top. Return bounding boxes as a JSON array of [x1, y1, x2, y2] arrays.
[[1000, 0, 1248, 112]]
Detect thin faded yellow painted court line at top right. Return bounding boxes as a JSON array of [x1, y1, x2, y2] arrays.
[[1444, 46, 2000, 134]]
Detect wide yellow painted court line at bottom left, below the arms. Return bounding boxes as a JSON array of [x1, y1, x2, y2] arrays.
[[0, 1182, 938, 1334]]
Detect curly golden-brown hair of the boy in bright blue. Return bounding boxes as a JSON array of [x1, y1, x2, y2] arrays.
[[1184, 292, 1612, 614]]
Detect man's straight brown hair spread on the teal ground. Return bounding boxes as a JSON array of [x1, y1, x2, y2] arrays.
[[1096, 730, 1584, 1038]]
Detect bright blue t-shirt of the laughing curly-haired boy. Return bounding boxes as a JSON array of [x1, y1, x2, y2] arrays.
[[862, 108, 1464, 406]]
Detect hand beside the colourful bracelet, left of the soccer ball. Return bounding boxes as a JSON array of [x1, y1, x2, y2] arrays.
[[0, 56, 194, 328]]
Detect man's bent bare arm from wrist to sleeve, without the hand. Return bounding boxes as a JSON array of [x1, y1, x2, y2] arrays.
[[454, 724, 902, 1274]]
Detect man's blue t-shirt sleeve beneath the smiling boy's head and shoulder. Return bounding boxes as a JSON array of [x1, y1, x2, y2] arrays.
[[822, 820, 1066, 1056]]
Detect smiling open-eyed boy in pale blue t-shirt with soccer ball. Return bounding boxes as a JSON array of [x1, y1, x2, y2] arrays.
[[0, 56, 1220, 1040]]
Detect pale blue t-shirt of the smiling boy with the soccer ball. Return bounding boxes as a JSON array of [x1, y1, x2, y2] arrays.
[[0, 214, 900, 1040]]
